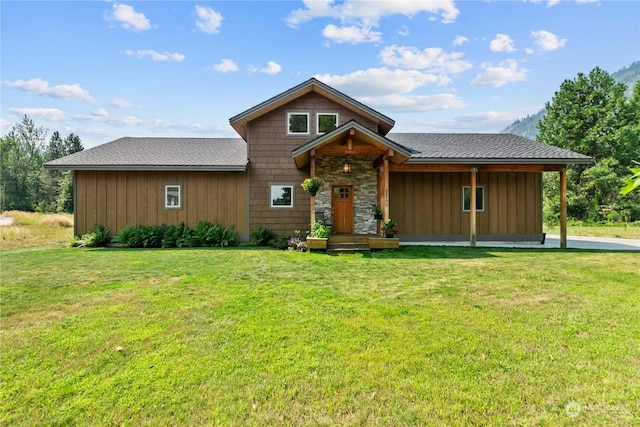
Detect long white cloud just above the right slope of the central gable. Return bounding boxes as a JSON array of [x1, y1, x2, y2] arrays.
[[315, 68, 440, 97]]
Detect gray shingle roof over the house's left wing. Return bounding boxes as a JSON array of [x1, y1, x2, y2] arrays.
[[45, 137, 248, 171]]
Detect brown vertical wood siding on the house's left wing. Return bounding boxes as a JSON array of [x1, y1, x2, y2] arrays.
[[75, 170, 249, 240]]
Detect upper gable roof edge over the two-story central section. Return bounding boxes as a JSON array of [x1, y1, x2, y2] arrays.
[[229, 78, 395, 141]]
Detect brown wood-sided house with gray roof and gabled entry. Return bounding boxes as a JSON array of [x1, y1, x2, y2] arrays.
[[45, 78, 592, 246]]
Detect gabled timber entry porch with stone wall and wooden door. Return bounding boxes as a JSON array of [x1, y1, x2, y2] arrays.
[[293, 121, 411, 237]]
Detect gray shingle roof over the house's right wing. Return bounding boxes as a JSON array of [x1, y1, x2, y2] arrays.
[[387, 133, 592, 164]]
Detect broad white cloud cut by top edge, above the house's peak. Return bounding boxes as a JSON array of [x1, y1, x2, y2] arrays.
[[285, 0, 460, 43]]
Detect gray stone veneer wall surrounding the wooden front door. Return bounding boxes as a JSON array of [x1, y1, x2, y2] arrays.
[[315, 155, 378, 234]]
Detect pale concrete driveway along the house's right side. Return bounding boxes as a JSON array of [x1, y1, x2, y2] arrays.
[[400, 235, 640, 252]]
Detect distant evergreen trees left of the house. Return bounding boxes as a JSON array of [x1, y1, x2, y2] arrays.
[[0, 115, 84, 212]]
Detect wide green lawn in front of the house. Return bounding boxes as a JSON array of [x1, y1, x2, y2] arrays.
[[0, 247, 640, 426]]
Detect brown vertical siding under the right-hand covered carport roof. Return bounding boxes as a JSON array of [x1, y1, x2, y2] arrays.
[[389, 172, 542, 240]]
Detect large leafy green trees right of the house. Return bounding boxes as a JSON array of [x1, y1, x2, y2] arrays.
[[536, 67, 640, 222]]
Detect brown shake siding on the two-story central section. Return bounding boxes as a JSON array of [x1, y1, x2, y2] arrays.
[[248, 93, 376, 235]]
